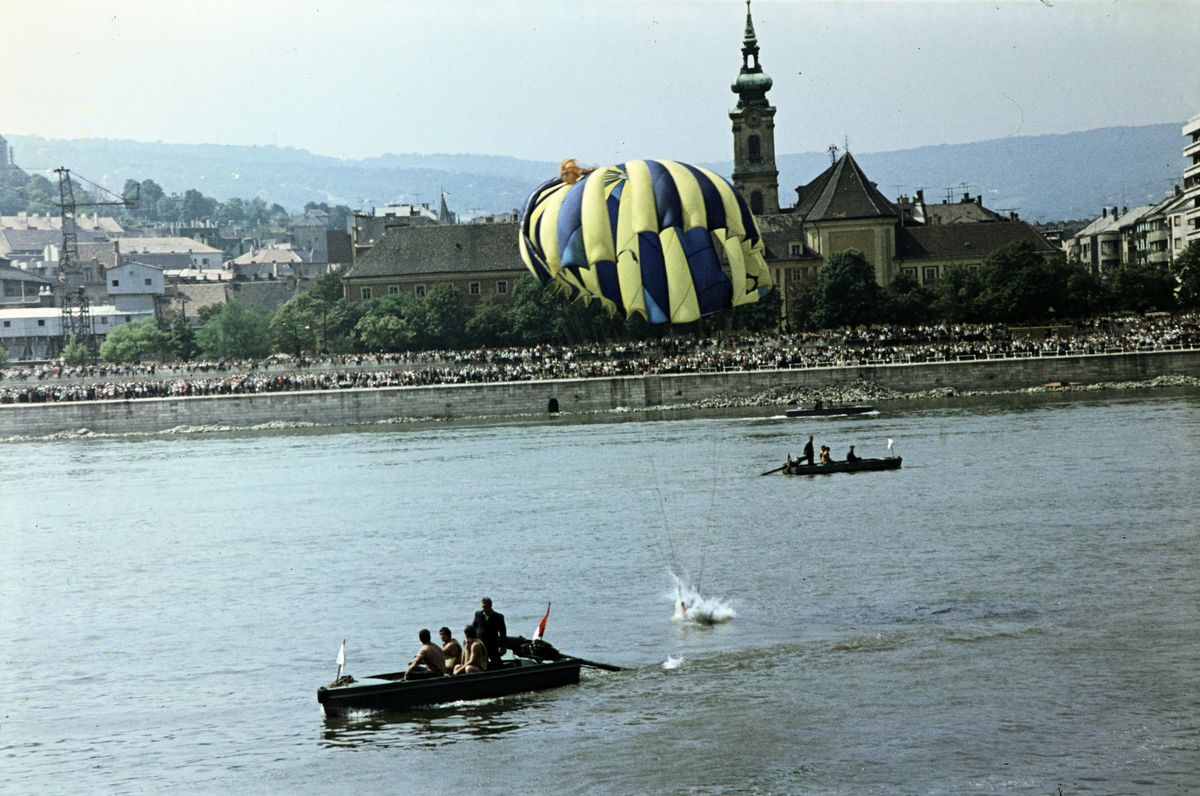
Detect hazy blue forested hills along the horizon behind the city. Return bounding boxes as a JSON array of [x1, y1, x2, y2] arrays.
[[7, 124, 1184, 221]]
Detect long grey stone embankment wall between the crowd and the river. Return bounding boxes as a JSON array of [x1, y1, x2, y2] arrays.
[[0, 349, 1200, 438]]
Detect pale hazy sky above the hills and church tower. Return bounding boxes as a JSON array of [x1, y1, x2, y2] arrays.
[[0, 0, 1200, 163]]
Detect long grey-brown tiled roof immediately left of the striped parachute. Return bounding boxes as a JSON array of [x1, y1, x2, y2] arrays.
[[346, 223, 524, 279]]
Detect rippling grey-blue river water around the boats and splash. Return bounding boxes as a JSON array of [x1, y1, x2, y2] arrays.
[[0, 393, 1200, 794]]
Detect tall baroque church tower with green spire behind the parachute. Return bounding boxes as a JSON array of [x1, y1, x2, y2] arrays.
[[730, 0, 779, 214]]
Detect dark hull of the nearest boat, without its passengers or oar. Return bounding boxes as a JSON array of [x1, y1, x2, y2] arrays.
[[317, 658, 582, 716]]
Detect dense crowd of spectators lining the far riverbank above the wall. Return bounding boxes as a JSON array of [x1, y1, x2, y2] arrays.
[[0, 315, 1200, 403]]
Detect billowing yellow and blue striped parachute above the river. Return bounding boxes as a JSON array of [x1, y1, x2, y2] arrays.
[[520, 161, 772, 324]]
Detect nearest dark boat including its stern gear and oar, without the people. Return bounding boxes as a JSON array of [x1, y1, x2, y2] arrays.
[[317, 636, 620, 716]]
